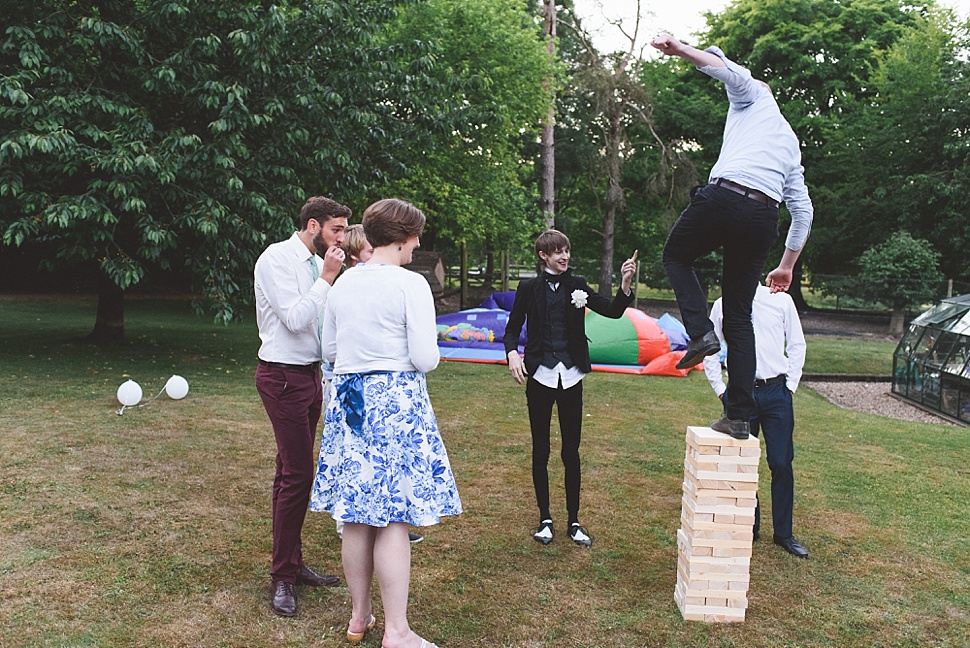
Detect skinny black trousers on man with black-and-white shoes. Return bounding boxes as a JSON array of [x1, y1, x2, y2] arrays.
[[525, 378, 583, 523]]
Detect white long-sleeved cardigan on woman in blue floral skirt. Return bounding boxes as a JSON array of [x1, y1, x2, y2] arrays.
[[323, 263, 440, 374]]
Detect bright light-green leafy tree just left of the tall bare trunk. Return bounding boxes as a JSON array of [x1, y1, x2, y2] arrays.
[[390, 0, 557, 284]]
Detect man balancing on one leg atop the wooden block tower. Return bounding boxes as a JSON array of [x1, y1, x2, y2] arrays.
[[651, 34, 814, 439]]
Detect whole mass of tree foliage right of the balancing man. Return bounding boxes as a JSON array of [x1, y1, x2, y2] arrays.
[[703, 0, 970, 292]]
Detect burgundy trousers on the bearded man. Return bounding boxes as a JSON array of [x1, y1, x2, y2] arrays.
[[256, 364, 323, 583]]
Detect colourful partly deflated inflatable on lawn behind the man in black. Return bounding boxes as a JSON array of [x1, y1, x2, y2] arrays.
[[437, 292, 701, 377]]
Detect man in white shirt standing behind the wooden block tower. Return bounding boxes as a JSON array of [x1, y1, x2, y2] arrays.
[[704, 286, 808, 558]]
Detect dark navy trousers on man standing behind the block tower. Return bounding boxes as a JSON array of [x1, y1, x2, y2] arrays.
[[751, 382, 795, 538]]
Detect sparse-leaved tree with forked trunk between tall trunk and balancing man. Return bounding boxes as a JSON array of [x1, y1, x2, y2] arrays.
[[556, 3, 686, 294]]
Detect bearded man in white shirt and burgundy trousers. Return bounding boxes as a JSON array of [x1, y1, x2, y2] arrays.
[[254, 196, 351, 616]]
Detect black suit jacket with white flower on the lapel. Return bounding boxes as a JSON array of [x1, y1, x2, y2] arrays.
[[505, 270, 633, 376]]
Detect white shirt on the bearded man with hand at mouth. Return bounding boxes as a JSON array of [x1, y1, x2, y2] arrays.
[[254, 232, 330, 365]]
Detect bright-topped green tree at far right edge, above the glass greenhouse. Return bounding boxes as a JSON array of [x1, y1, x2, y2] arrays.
[[813, 12, 970, 284]]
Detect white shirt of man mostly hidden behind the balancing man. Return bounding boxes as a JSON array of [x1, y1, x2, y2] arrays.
[[704, 286, 806, 396]]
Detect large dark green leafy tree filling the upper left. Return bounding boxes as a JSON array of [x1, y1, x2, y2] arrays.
[[0, 0, 431, 340]]
